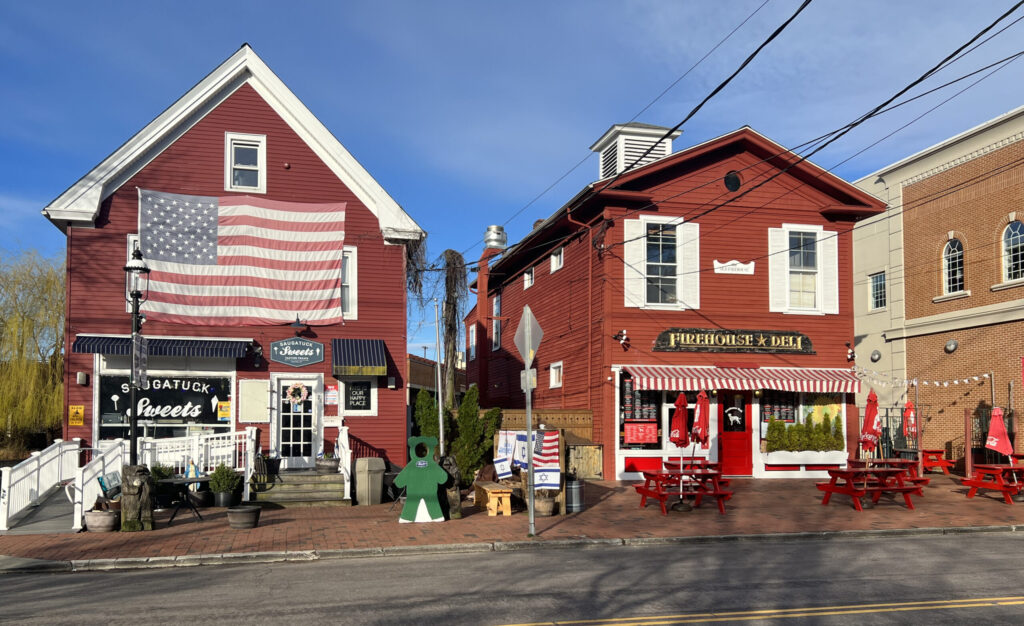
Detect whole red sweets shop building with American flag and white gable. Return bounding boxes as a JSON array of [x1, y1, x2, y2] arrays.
[[44, 45, 424, 467]]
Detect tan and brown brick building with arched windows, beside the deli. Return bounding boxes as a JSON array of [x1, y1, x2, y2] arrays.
[[855, 103, 1024, 458]]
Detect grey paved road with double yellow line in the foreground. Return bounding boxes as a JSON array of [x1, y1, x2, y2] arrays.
[[6, 533, 1024, 624]]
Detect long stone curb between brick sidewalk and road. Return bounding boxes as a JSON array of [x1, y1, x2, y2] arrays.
[[0, 525, 1024, 575]]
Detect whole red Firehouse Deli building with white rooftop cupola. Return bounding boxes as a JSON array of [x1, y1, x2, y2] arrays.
[[466, 124, 884, 479]]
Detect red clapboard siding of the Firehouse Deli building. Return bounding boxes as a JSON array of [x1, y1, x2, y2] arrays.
[[470, 129, 880, 476]]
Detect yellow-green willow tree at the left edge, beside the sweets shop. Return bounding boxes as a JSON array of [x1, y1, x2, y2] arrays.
[[0, 251, 65, 448]]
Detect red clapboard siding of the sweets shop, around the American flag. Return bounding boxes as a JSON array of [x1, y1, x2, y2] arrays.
[[65, 85, 408, 463]]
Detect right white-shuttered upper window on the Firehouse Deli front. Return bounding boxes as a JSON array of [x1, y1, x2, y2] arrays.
[[768, 224, 839, 315]]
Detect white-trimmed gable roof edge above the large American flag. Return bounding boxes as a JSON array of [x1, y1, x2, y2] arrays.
[[42, 44, 424, 241]]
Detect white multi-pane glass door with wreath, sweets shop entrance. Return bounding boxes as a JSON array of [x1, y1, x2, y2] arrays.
[[273, 376, 324, 469]]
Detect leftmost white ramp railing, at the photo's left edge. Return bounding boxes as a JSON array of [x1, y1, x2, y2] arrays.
[[0, 439, 82, 531]]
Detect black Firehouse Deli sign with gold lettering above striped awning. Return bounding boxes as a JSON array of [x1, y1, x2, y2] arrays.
[[653, 328, 815, 354]]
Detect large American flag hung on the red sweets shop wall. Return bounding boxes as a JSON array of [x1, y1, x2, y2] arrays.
[[139, 190, 345, 326]]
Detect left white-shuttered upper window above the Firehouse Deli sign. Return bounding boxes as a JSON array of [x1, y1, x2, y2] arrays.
[[623, 215, 700, 310]]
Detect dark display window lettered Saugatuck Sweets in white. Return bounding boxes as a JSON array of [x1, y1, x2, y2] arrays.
[[99, 375, 231, 439]]
